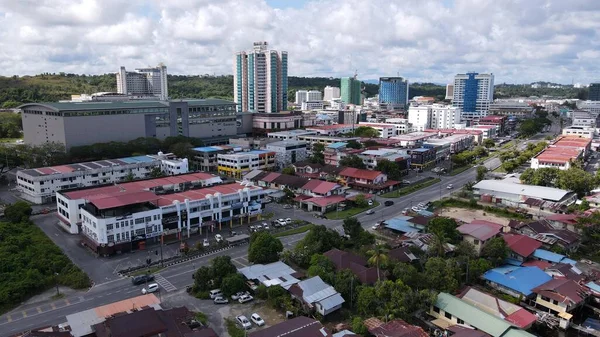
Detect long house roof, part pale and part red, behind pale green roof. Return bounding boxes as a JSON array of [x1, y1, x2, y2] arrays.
[[456, 287, 536, 330]]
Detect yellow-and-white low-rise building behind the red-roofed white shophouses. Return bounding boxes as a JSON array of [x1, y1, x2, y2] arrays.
[[217, 150, 277, 179]]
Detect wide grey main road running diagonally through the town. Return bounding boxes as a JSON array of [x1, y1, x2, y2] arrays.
[[0, 158, 500, 336]]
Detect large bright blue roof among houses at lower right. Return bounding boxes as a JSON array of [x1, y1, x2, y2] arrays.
[[483, 266, 552, 296]]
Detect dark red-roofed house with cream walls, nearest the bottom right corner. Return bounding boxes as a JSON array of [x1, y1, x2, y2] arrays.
[[533, 279, 591, 329]]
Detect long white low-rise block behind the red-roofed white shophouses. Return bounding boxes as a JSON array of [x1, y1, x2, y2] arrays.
[[16, 152, 188, 204]]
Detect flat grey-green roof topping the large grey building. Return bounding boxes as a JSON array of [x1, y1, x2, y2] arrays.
[[19, 98, 235, 112]]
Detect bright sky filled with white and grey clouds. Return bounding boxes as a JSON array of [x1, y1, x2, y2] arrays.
[[0, 0, 600, 84]]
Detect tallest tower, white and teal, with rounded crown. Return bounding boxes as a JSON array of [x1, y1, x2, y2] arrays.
[[233, 42, 288, 113]]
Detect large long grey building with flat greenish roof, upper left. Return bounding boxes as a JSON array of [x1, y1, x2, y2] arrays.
[[19, 99, 252, 149]]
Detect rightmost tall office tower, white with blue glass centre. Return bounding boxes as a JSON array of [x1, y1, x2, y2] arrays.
[[452, 73, 494, 119]]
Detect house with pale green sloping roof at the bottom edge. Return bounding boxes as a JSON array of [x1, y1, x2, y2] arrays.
[[429, 293, 534, 337]]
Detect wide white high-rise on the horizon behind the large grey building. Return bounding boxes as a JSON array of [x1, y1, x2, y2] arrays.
[[117, 63, 169, 101]]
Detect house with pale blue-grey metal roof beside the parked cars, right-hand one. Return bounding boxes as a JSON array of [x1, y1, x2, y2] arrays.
[[288, 276, 344, 316]]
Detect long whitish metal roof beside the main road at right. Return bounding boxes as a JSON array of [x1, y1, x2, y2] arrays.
[[473, 180, 571, 201]]
